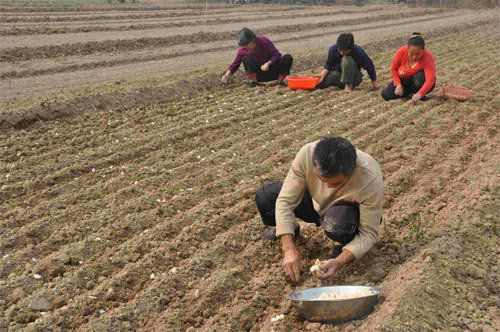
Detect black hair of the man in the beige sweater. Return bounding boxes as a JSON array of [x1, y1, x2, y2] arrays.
[[313, 136, 356, 178]]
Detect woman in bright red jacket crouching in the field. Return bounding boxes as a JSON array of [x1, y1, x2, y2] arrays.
[[382, 32, 436, 102]]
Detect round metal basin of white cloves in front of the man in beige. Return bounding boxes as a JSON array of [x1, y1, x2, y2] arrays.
[[287, 286, 382, 323]]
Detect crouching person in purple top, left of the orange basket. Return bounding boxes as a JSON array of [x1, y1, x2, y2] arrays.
[[222, 28, 293, 87]]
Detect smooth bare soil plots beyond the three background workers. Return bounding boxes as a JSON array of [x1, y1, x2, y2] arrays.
[[0, 2, 498, 102]]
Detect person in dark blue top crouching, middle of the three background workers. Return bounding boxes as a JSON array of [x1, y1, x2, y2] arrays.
[[318, 33, 379, 92]]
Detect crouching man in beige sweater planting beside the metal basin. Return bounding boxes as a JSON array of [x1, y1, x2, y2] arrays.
[[255, 137, 383, 282]]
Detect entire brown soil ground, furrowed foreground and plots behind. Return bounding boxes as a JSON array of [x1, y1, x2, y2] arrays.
[[0, 2, 500, 332]]
